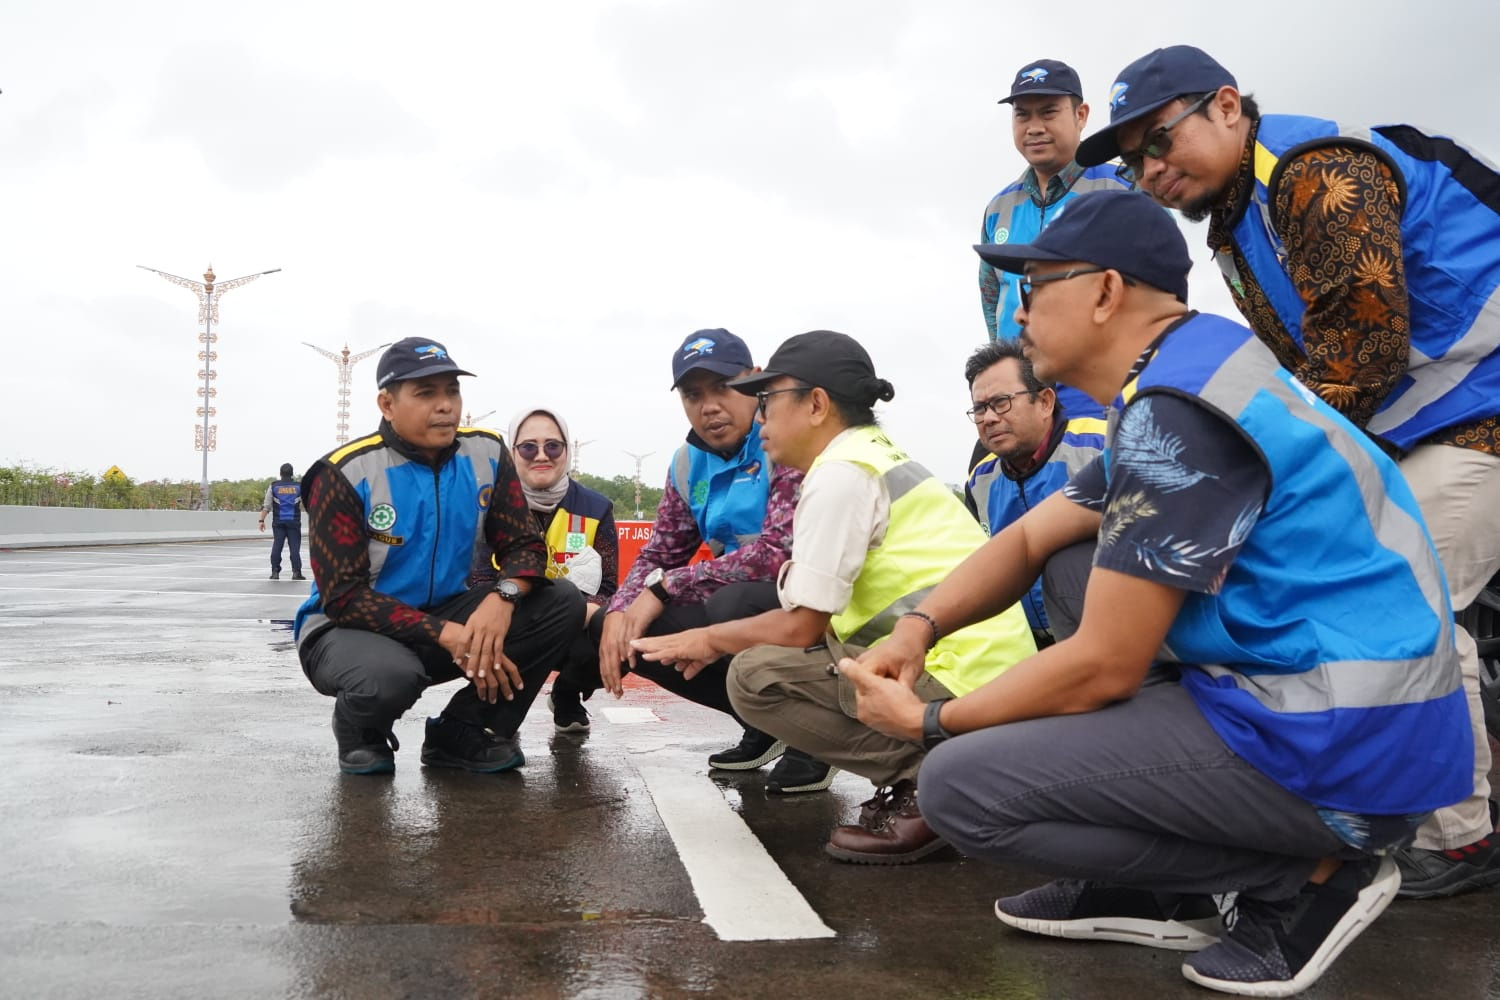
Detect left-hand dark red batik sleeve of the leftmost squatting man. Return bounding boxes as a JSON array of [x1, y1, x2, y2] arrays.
[[303, 462, 444, 645]]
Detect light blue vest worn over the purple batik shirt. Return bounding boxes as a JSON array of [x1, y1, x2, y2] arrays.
[[672, 433, 773, 558]]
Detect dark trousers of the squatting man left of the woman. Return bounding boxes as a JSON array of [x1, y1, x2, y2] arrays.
[[299, 580, 584, 736]]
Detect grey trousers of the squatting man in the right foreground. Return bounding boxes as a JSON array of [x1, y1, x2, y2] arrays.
[[920, 681, 1358, 900]]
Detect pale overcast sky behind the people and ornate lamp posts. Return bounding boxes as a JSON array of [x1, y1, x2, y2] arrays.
[[0, 0, 1500, 484]]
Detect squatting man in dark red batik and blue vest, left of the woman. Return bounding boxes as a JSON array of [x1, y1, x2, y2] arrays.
[[296, 337, 584, 775]]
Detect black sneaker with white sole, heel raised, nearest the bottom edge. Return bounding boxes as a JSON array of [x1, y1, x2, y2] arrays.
[[1182, 858, 1401, 997]]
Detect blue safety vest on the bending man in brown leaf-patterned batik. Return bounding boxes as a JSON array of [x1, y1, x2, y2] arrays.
[[1217, 114, 1500, 448]]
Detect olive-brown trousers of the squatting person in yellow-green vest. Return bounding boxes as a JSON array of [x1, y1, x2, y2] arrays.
[[726, 634, 951, 786]]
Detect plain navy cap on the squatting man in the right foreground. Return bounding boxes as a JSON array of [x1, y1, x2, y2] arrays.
[[974, 190, 1193, 303]]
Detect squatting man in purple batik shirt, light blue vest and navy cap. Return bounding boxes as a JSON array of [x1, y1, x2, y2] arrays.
[[590, 330, 837, 795]]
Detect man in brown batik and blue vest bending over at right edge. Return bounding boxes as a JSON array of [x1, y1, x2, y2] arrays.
[[1079, 45, 1500, 898]]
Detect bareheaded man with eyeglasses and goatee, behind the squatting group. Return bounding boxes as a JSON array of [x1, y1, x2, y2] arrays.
[[963, 340, 1104, 648]]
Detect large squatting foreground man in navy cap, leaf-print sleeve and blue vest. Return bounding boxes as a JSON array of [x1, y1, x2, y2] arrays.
[[840, 192, 1473, 997]]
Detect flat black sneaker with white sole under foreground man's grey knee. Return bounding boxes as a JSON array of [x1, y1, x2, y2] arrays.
[[995, 879, 1224, 952]]
